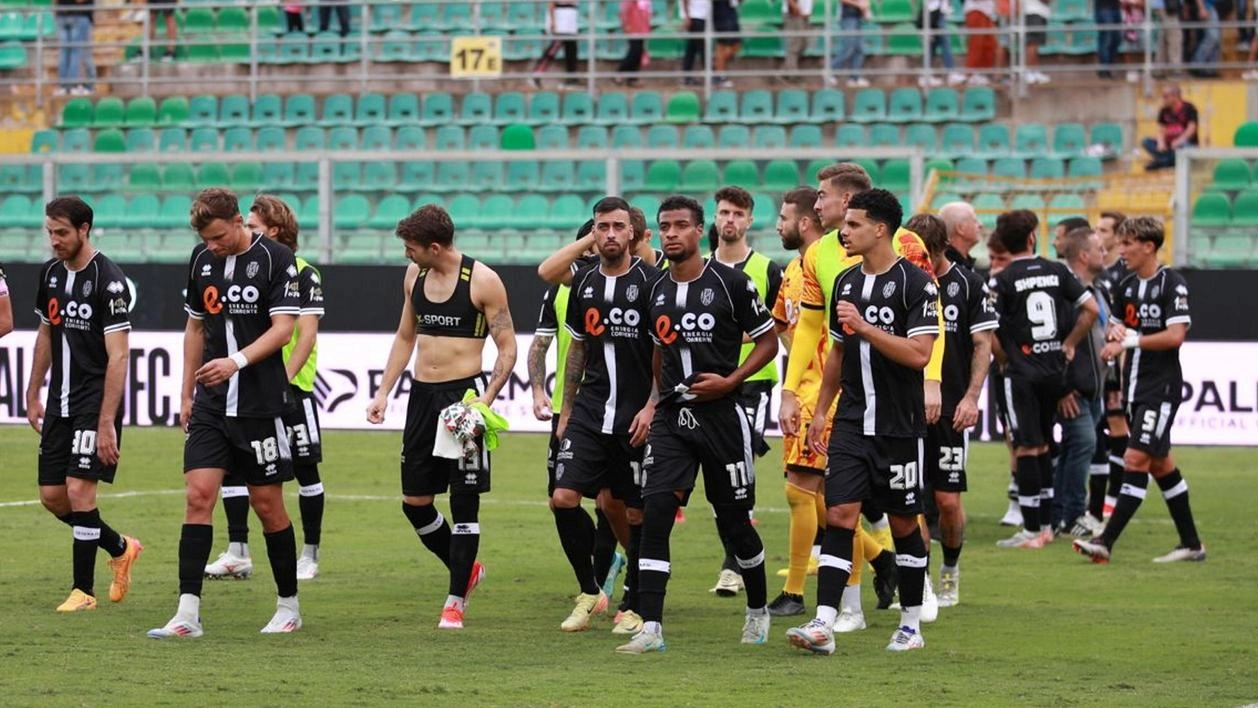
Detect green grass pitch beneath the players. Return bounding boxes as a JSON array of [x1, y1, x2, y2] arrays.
[[0, 428, 1258, 705]]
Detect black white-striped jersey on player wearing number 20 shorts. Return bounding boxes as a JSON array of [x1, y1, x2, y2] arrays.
[[829, 258, 940, 438]]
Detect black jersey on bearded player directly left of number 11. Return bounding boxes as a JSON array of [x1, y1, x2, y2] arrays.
[[564, 258, 659, 435]]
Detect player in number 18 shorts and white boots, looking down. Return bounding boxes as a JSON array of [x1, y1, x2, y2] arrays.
[[148, 189, 302, 639]]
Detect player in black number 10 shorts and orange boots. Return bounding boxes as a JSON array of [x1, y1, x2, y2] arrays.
[[26, 196, 143, 612]]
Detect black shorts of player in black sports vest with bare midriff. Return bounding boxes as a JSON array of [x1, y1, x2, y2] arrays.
[[401, 376, 489, 497]]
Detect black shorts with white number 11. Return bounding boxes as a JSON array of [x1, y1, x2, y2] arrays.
[[642, 399, 756, 509]]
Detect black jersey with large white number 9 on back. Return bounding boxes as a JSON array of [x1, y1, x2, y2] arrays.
[[991, 255, 1092, 381]]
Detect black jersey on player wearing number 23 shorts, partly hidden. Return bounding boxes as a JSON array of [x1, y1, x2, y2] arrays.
[[938, 263, 1000, 419]]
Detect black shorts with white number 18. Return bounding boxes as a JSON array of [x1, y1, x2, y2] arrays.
[[184, 405, 293, 487]]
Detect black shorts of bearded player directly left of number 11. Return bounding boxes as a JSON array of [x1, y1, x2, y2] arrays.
[[555, 419, 643, 508]]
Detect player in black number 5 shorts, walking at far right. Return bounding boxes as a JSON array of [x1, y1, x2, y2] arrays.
[[1074, 216, 1205, 563]]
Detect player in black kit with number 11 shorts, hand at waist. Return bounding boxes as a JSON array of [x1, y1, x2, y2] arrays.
[[616, 196, 777, 654]]
